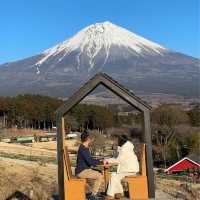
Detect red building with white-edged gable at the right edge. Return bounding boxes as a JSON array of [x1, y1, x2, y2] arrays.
[[165, 157, 200, 174]]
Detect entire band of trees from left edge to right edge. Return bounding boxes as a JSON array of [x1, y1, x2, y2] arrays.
[[0, 94, 200, 167]]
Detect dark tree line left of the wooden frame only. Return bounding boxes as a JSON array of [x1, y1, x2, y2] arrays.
[[0, 94, 62, 129]]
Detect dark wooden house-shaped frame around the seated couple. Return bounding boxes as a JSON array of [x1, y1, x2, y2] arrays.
[[56, 73, 155, 199]]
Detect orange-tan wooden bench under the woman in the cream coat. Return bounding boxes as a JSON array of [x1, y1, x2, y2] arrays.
[[125, 144, 148, 200]]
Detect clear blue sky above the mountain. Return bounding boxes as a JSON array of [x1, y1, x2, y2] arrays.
[[0, 0, 200, 63]]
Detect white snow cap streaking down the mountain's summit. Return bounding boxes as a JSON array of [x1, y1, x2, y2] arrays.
[[36, 21, 167, 68]]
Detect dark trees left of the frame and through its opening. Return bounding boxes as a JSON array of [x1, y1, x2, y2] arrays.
[[0, 94, 136, 131]]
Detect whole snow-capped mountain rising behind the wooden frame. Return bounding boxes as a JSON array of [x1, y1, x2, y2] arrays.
[[0, 22, 200, 97]]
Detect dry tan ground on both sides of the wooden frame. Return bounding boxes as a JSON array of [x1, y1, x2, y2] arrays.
[[0, 140, 200, 200]]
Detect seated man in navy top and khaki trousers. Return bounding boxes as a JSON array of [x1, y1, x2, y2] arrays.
[[75, 132, 104, 200]]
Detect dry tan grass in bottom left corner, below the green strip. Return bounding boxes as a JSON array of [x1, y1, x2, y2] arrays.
[[0, 159, 57, 200]]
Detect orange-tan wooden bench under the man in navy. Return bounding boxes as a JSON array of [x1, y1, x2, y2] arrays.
[[63, 146, 86, 200]]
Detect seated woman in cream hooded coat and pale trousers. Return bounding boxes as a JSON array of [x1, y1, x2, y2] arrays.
[[104, 135, 139, 199]]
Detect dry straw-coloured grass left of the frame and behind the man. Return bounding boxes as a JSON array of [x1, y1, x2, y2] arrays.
[[0, 140, 77, 200]]
